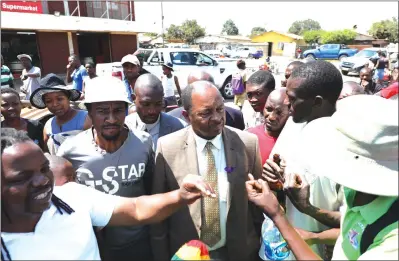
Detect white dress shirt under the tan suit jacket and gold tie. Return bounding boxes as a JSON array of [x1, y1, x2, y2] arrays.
[[194, 133, 229, 251]]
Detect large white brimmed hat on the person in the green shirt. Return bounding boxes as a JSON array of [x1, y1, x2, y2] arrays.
[[302, 95, 399, 196]]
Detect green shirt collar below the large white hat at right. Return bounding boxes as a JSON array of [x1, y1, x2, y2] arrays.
[[344, 187, 397, 224]]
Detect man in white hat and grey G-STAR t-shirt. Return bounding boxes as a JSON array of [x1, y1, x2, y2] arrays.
[[57, 76, 154, 261]]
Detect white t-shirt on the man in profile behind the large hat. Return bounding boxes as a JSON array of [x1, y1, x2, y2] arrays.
[[270, 117, 344, 255]]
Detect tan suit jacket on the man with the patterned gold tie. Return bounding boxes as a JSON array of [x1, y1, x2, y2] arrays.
[[151, 126, 263, 261]]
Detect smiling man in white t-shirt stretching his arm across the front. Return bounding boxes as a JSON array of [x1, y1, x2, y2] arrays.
[[1, 128, 216, 260]]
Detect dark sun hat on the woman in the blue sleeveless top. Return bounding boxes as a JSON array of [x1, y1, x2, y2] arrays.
[[30, 73, 81, 109]]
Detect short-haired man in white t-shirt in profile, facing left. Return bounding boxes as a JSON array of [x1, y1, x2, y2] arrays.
[[263, 61, 343, 258]]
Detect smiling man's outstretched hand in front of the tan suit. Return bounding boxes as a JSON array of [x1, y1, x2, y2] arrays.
[[179, 174, 216, 204]]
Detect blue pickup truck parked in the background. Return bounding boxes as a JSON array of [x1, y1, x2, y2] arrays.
[[303, 44, 358, 60]]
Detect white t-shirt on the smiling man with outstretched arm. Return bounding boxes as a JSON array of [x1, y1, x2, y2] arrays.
[[1, 182, 118, 260]]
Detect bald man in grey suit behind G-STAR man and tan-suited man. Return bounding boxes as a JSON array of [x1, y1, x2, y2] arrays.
[[125, 73, 187, 150]]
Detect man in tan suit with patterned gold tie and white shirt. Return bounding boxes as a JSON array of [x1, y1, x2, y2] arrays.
[[151, 81, 263, 261]]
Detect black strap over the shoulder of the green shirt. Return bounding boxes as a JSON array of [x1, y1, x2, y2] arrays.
[[360, 200, 399, 255]]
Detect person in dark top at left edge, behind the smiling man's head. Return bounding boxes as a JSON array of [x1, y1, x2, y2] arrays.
[[1, 88, 46, 149]]
